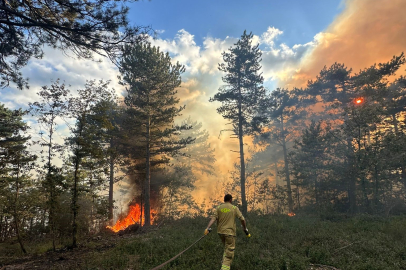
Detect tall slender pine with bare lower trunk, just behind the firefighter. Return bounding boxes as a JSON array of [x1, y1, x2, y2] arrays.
[[210, 31, 265, 213]]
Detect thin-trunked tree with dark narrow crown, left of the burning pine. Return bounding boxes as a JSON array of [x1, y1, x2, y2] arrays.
[[66, 81, 114, 247]]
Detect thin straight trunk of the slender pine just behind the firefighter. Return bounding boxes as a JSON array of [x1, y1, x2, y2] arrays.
[[238, 78, 248, 215]]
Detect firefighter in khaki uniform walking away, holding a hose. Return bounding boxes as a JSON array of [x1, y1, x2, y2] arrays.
[[204, 194, 248, 270]]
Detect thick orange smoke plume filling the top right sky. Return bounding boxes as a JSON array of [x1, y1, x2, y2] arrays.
[[286, 0, 406, 87]]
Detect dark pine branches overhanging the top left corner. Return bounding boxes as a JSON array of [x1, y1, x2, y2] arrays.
[[0, 0, 148, 88]]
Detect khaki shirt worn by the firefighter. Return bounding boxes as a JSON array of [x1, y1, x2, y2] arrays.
[[213, 202, 244, 236]]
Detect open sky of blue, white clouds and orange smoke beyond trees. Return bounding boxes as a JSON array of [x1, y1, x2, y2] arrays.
[[0, 0, 406, 205]]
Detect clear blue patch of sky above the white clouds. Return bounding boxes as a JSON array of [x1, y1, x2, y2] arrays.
[[130, 0, 344, 46]]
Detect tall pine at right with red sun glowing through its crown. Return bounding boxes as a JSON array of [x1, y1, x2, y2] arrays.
[[306, 54, 405, 213]]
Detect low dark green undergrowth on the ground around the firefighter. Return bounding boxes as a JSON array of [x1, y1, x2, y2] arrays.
[[3, 215, 406, 270]]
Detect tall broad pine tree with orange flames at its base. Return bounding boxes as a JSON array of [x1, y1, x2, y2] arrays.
[[120, 44, 191, 225]]
